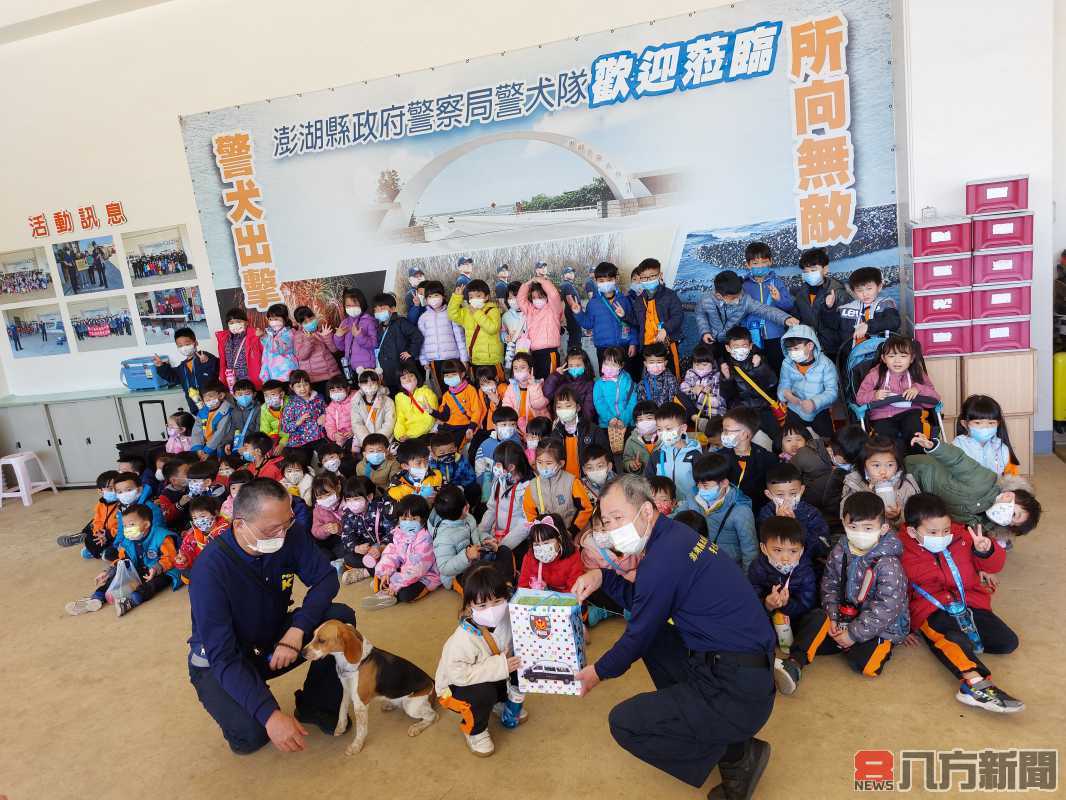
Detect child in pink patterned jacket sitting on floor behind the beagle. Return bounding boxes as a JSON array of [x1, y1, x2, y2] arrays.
[[362, 495, 440, 610]]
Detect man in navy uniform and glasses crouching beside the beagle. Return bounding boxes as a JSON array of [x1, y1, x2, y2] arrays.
[[189, 478, 355, 753]]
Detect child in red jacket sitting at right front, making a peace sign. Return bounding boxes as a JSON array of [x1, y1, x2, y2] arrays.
[[900, 493, 1025, 714]]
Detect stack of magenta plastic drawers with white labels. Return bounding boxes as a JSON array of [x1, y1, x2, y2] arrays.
[[910, 175, 1033, 355]]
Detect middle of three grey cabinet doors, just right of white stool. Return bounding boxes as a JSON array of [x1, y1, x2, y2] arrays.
[[48, 398, 124, 484]]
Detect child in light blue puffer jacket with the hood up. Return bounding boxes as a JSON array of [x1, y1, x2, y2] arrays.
[[777, 325, 840, 438]]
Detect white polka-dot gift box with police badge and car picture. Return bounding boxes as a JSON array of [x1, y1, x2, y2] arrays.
[[508, 589, 585, 694]]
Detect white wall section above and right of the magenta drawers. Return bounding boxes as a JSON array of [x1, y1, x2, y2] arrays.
[[897, 0, 1066, 451]]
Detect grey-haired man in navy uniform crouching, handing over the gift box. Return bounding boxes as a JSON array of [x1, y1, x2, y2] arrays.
[[574, 475, 775, 800]]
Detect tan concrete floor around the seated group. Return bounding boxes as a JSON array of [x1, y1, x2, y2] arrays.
[[0, 457, 1066, 800]]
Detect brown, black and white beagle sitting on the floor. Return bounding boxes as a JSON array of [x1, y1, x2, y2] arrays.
[[303, 620, 437, 755]]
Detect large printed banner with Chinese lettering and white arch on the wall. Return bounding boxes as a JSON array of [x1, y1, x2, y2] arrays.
[[182, 0, 899, 345]]
